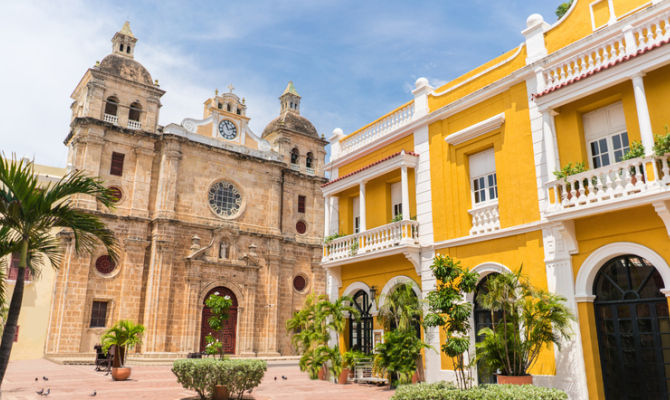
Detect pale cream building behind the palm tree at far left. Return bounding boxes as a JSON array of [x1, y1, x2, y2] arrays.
[[0, 160, 65, 360]]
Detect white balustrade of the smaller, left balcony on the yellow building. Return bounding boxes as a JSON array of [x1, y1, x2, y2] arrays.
[[321, 220, 419, 266]]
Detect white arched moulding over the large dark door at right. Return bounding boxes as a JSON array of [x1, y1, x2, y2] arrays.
[[575, 242, 670, 299]]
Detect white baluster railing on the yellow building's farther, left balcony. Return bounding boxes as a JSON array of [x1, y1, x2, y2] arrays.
[[322, 220, 419, 262]]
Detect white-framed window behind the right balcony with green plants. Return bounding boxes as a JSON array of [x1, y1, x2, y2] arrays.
[[582, 102, 630, 168]]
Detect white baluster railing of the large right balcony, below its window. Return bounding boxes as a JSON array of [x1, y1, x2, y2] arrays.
[[544, 154, 670, 216]]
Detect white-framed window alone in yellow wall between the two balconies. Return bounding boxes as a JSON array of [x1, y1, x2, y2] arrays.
[[469, 148, 498, 207]]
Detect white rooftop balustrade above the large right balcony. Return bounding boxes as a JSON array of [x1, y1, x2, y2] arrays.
[[540, 9, 670, 92]]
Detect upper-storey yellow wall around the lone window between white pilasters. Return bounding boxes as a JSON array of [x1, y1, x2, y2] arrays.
[[429, 83, 540, 242]]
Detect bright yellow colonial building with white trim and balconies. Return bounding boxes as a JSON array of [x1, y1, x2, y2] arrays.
[[323, 0, 670, 399]]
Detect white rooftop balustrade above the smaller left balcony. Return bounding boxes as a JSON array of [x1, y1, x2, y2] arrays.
[[338, 102, 414, 157]]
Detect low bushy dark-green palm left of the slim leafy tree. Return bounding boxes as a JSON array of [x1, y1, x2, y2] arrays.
[[374, 329, 429, 387]]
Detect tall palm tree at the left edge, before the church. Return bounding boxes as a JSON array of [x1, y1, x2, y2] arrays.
[[0, 157, 118, 385]]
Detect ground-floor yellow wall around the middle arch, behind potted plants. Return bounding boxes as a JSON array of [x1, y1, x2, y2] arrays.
[[435, 231, 556, 375]]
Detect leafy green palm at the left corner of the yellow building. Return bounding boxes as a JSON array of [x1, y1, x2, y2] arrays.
[[286, 294, 359, 379]]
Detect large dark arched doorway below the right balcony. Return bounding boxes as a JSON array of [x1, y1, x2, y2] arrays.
[[593, 254, 670, 400]]
